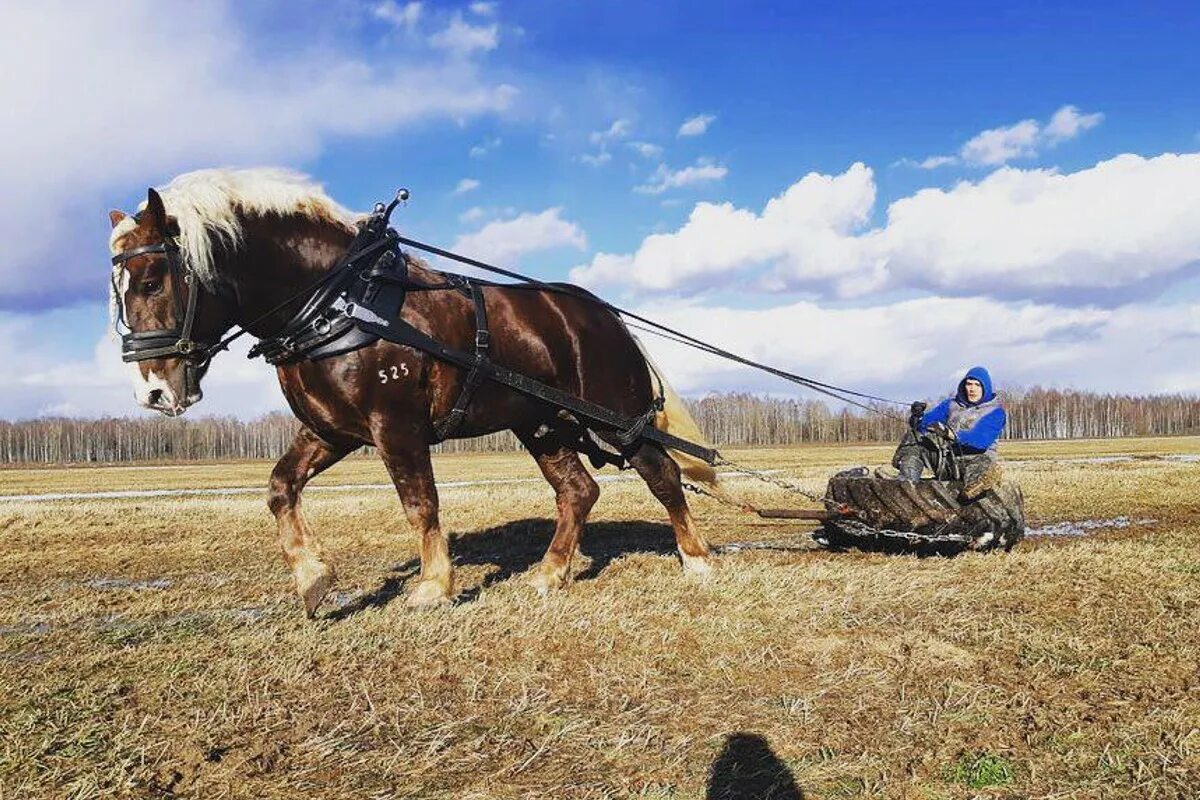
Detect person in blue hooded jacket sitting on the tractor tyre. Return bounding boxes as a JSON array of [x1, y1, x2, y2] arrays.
[[892, 367, 1008, 485]]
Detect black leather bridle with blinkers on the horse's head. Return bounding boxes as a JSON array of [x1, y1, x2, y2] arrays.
[[112, 239, 212, 368]]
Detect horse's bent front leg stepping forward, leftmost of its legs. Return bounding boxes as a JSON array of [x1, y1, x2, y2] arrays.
[[268, 428, 355, 618]]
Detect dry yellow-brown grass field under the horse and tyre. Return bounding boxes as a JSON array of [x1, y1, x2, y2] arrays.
[[0, 439, 1200, 800]]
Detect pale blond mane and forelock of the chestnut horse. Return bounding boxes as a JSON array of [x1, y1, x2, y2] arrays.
[[108, 167, 356, 289]]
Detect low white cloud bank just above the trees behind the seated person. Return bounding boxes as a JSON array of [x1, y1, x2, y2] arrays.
[[637, 297, 1200, 398]]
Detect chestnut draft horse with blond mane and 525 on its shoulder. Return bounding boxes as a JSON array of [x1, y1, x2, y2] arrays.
[[109, 168, 716, 618]]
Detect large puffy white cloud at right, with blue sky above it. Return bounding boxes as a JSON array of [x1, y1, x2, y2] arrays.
[[571, 154, 1200, 303]]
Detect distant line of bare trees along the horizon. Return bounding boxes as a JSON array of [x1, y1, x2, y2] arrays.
[[0, 389, 1200, 464]]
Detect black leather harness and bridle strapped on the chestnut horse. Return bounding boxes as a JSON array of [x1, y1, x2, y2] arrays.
[[113, 196, 718, 467]]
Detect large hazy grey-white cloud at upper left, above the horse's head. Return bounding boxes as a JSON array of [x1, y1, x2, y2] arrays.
[[0, 0, 516, 305]]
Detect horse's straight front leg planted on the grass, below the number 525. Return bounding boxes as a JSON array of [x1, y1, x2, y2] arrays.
[[377, 437, 454, 608]]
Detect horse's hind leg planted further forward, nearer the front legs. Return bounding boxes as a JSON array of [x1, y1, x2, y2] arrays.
[[517, 432, 600, 595]]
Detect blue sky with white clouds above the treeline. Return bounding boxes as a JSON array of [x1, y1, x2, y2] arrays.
[[0, 0, 1200, 419]]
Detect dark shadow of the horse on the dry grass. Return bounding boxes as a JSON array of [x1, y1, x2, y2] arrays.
[[325, 518, 676, 621]]
